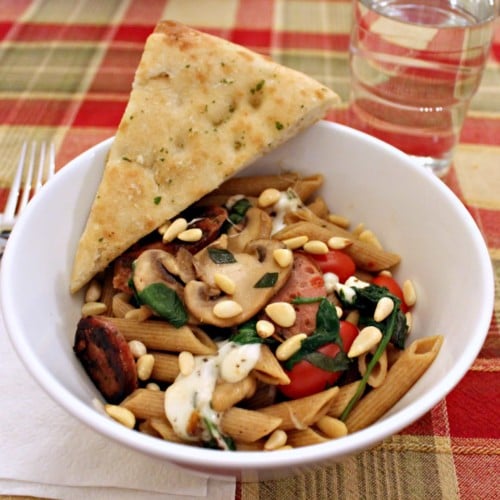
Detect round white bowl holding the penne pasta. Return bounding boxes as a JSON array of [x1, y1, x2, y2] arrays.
[[1, 122, 494, 480]]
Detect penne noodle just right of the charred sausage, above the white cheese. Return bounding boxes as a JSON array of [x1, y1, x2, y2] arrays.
[[105, 318, 217, 355]]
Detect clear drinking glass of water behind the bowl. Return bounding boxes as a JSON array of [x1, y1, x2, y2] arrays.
[[350, 0, 495, 176]]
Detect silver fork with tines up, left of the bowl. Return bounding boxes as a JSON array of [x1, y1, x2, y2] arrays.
[[0, 141, 55, 256]]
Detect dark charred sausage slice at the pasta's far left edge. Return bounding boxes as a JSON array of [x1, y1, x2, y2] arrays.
[[73, 316, 138, 404]]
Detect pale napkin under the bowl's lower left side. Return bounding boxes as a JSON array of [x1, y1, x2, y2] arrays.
[[0, 300, 235, 500]]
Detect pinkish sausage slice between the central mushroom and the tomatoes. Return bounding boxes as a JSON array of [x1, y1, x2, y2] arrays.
[[266, 252, 326, 338]]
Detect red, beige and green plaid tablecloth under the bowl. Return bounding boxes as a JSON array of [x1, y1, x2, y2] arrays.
[[0, 0, 500, 500]]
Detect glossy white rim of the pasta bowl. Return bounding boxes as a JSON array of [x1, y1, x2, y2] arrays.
[[0, 121, 494, 474]]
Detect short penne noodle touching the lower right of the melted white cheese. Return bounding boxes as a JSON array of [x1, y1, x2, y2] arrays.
[[220, 406, 281, 443]]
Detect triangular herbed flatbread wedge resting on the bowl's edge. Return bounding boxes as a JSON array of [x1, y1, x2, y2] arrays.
[[70, 21, 338, 292]]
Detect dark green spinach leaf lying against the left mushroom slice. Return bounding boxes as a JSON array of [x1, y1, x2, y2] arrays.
[[137, 283, 188, 328]]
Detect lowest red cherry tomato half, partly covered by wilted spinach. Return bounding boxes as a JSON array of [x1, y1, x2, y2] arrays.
[[278, 321, 359, 399]]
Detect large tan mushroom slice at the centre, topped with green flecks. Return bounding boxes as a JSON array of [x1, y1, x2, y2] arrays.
[[184, 238, 292, 328]]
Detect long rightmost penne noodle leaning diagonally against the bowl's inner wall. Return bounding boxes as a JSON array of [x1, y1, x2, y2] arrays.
[[345, 335, 444, 433]]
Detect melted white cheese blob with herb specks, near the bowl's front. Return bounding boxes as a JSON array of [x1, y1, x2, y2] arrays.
[[165, 341, 260, 441]]
